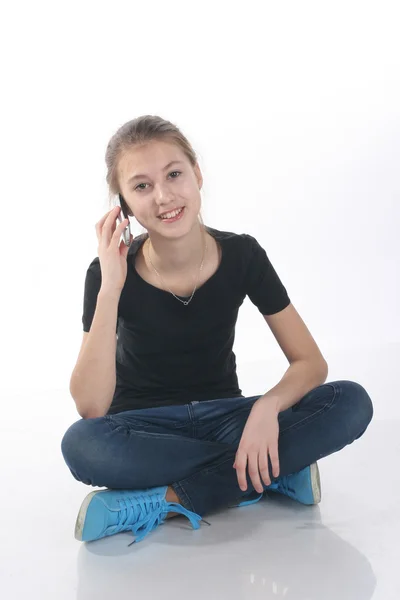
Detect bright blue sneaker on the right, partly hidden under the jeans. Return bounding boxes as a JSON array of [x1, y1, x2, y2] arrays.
[[236, 462, 321, 506]]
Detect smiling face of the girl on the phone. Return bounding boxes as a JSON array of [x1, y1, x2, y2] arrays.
[[118, 141, 203, 237]]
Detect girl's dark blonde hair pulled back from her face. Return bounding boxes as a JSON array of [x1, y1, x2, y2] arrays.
[[105, 115, 205, 231]]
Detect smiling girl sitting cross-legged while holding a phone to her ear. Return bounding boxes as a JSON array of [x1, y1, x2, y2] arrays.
[[61, 115, 373, 543]]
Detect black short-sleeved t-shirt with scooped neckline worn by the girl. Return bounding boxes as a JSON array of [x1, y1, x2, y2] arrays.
[[82, 227, 290, 414]]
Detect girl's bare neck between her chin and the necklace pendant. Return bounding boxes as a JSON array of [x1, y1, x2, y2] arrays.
[[146, 223, 207, 275]]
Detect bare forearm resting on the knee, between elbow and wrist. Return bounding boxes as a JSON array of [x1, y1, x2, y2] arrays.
[[259, 360, 328, 413]]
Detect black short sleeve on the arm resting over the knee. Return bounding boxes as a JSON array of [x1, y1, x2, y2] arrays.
[[243, 234, 290, 315]]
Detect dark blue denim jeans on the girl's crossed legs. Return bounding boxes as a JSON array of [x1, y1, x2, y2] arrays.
[[61, 381, 373, 516]]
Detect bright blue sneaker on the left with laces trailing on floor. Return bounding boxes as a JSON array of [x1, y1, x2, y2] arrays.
[[75, 486, 209, 546]]
